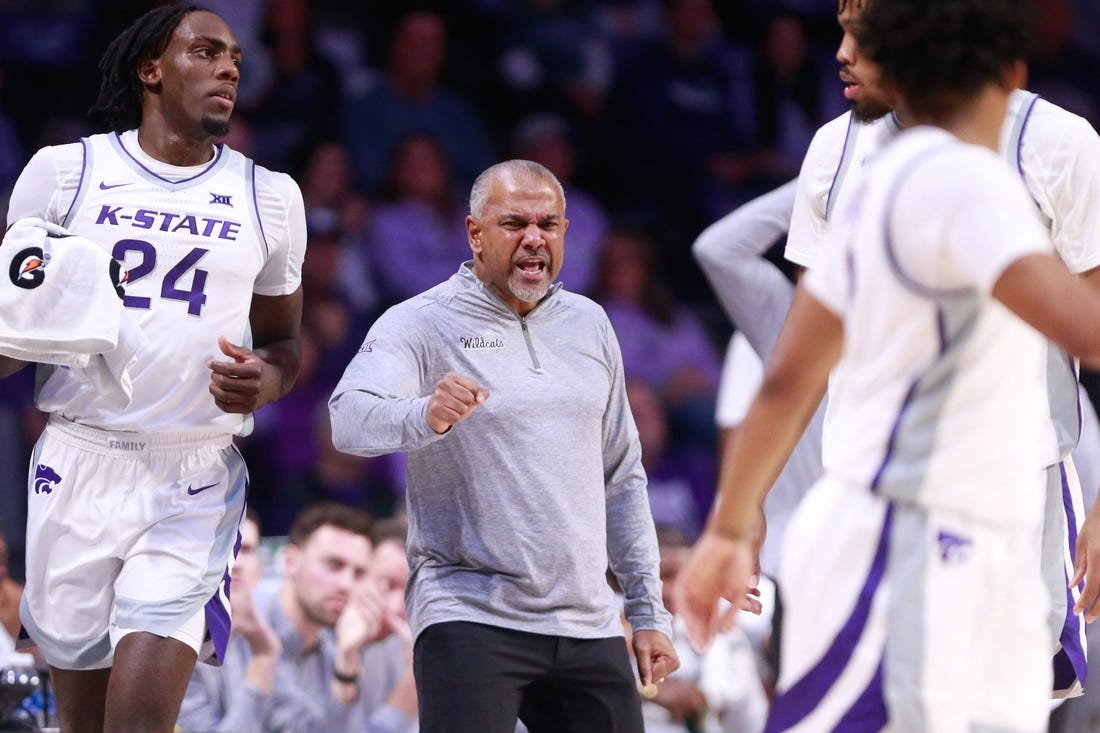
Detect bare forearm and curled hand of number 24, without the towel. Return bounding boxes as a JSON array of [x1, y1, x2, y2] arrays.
[[210, 287, 303, 413]]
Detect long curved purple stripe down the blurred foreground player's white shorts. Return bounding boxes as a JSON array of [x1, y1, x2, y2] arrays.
[[765, 503, 893, 733]]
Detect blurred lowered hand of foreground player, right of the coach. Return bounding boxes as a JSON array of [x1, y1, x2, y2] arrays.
[[672, 530, 760, 650]]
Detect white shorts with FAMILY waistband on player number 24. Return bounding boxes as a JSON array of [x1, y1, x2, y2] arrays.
[[20, 416, 248, 669]]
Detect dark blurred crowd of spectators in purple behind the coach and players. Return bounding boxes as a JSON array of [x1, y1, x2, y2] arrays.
[[0, 0, 1100, 579]]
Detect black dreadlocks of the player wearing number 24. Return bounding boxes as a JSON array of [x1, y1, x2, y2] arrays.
[[88, 4, 201, 132]]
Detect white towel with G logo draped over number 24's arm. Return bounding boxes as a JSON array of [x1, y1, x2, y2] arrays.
[[0, 218, 147, 407]]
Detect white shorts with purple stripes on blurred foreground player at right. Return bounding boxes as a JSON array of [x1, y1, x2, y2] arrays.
[[767, 477, 1052, 733]]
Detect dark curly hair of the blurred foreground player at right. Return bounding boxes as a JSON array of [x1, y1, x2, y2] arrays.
[[857, 0, 1035, 119]]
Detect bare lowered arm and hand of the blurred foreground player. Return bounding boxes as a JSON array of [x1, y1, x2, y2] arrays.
[[675, 285, 844, 647]]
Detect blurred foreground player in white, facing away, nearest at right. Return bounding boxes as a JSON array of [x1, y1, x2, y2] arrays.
[[678, 0, 1100, 731]]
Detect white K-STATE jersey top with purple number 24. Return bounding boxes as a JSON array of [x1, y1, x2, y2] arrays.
[[12, 131, 305, 433]]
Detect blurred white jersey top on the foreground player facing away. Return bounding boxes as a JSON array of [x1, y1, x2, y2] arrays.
[[805, 128, 1052, 522]]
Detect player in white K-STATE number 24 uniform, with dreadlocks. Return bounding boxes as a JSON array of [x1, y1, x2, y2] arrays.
[[6, 6, 306, 732]]
